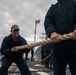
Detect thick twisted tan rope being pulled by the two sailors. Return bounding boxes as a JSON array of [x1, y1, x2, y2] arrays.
[[17, 33, 72, 50]]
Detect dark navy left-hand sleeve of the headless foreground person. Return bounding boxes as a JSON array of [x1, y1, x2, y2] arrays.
[[44, 6, 56, 37]]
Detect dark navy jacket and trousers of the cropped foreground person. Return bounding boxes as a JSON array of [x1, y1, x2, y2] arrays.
[[44, 0, 76, 75]]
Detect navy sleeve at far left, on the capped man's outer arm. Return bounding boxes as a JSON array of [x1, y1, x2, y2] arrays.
[[1, 38, 12, 56]]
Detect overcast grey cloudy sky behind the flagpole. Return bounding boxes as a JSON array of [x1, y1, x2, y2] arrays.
[[0, 0, 57, 45]]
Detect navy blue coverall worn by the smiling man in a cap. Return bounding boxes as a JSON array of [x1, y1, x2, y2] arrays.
[[0, 34, 31, 75]]
